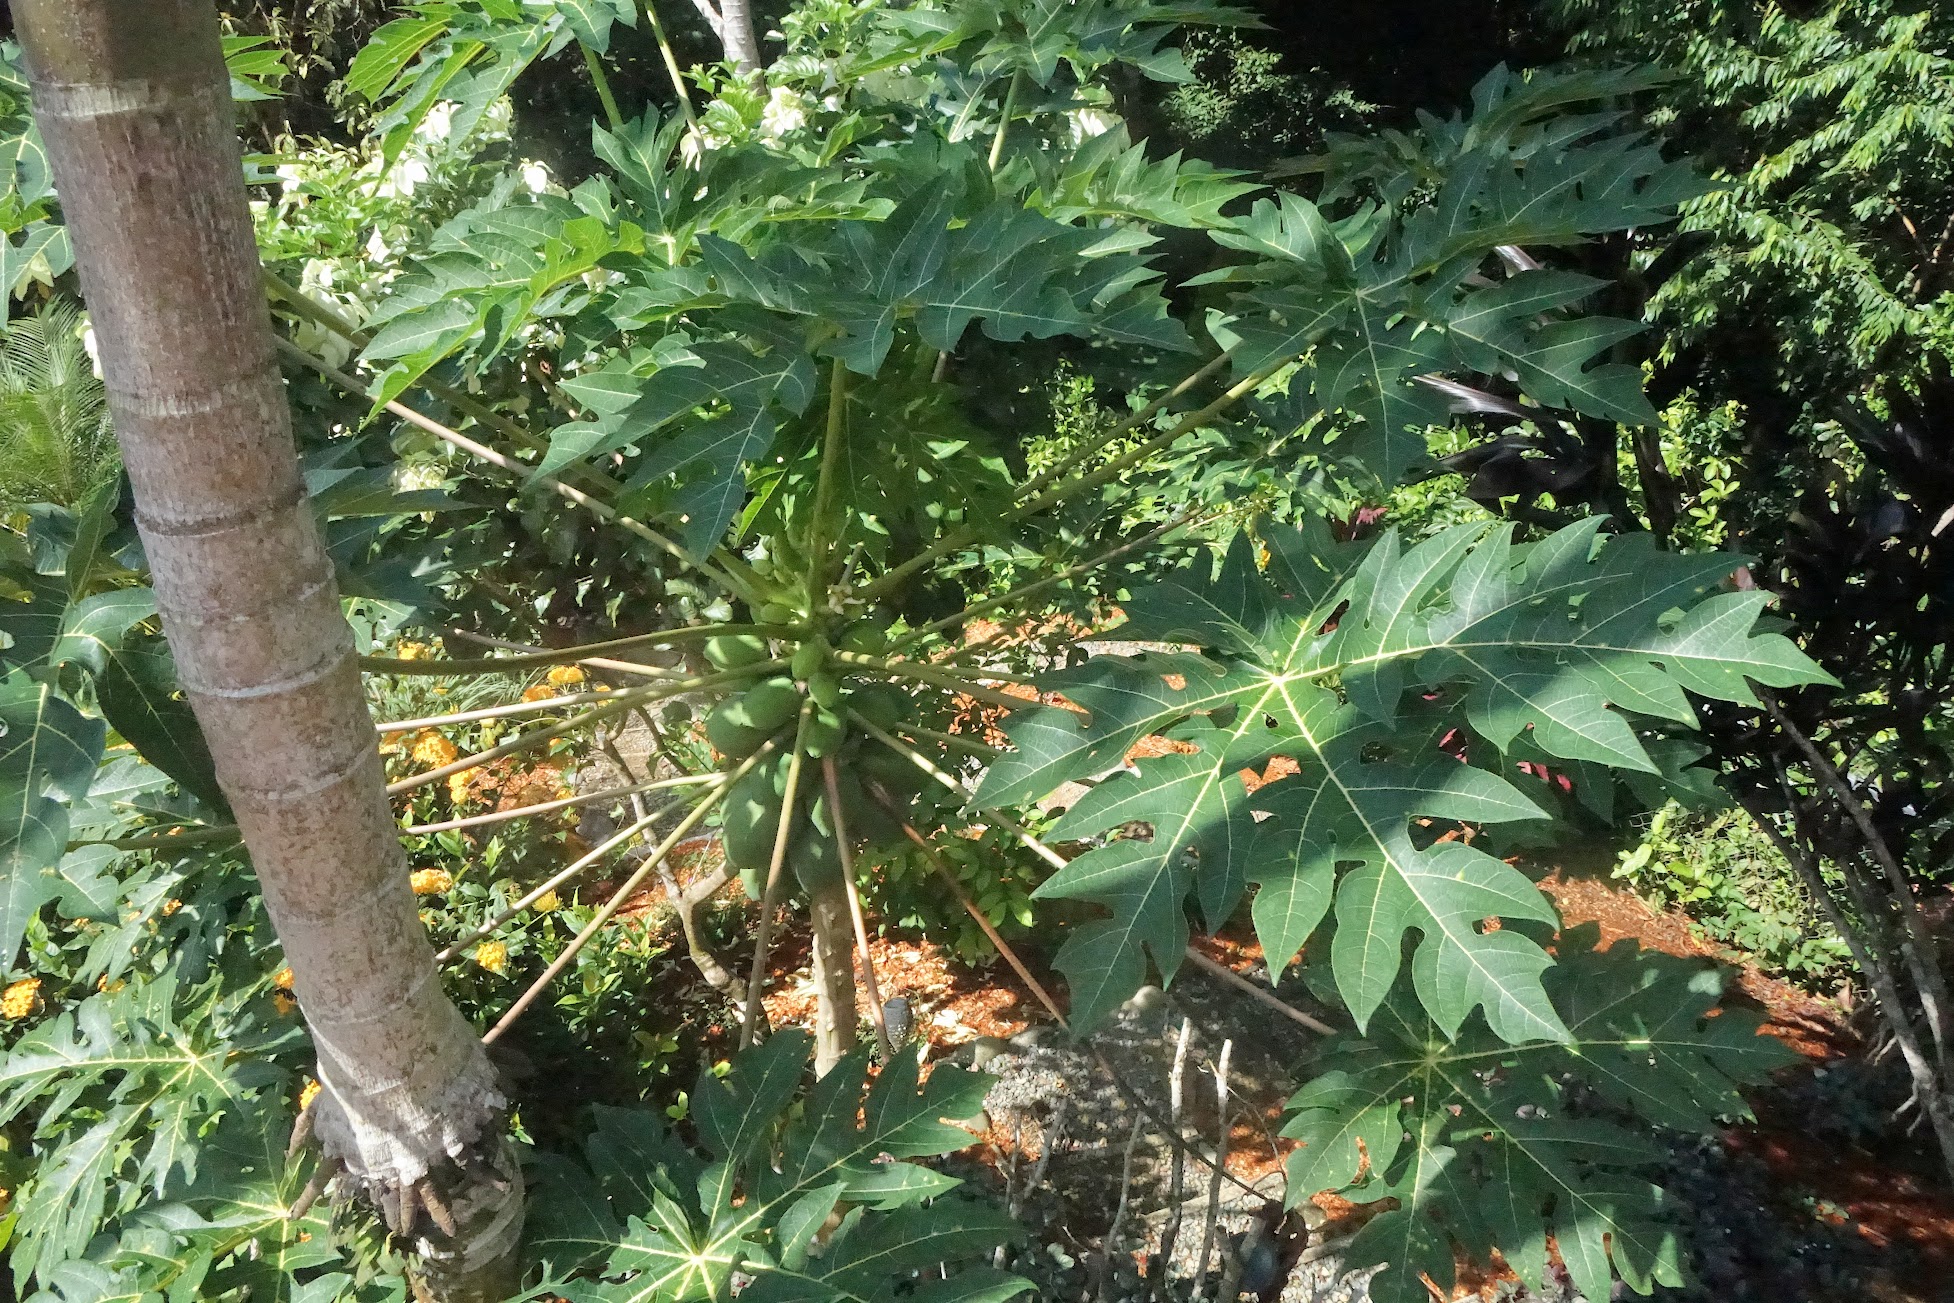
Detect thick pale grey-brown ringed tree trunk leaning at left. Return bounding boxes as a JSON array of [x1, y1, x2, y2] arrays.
[[12, 0, 522, 1301]]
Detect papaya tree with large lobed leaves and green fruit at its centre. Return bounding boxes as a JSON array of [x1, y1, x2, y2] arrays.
[[0, 0, 1821, 1303]]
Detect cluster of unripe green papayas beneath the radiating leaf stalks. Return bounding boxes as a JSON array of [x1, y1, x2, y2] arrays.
[[703, 621, 928, 899]]
